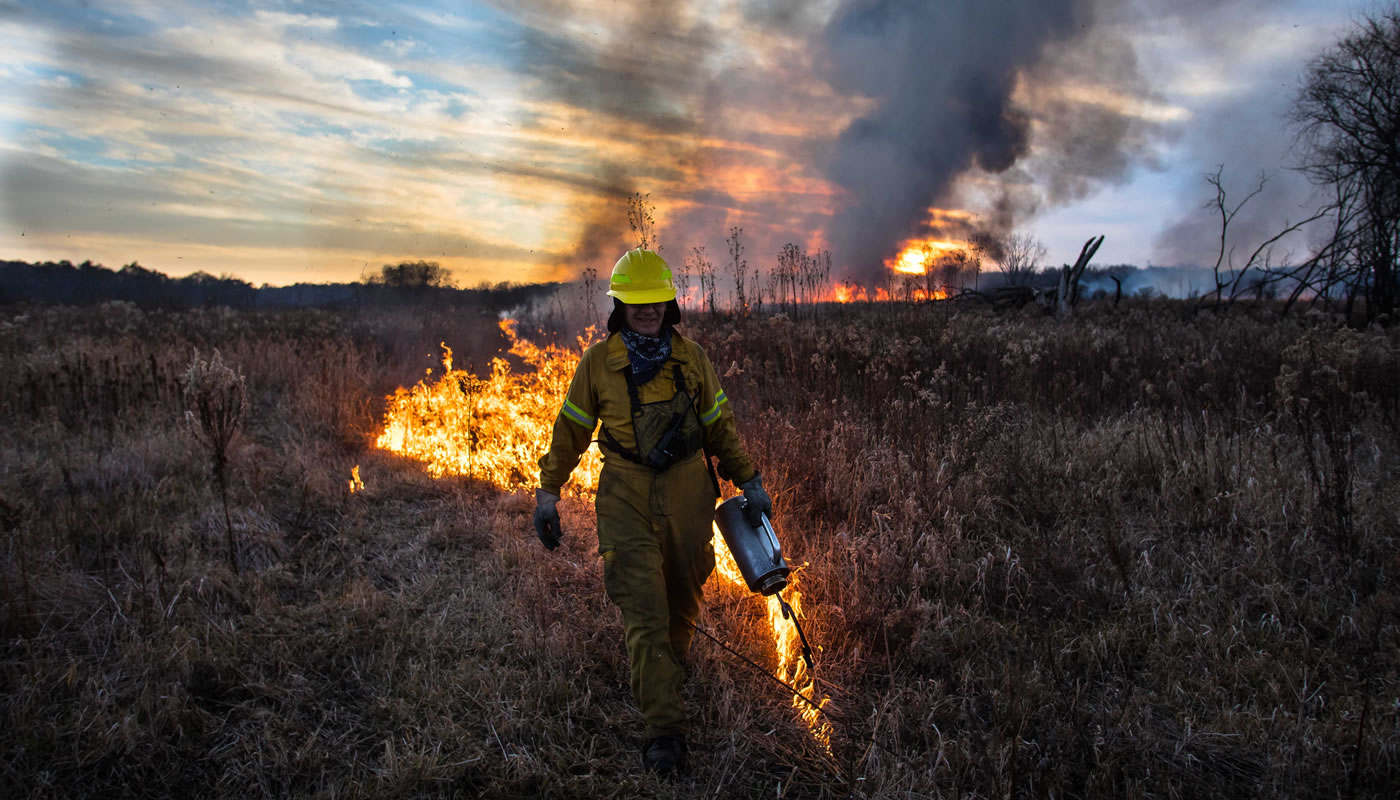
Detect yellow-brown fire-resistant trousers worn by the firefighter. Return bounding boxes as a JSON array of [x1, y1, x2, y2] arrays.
[[596, 453, 714, 738]]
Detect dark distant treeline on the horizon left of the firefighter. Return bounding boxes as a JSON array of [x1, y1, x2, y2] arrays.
[[0, 261, 559, 308]]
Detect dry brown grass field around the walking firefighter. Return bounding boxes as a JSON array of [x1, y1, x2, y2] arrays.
[[0, 301, 1400, 800]]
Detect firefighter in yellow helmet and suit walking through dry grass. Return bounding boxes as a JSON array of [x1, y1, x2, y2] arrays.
[[535, 249, 773, 773]]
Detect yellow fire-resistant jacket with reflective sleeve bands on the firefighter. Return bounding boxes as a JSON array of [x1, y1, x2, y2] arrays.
[[539, 332, 755, 495]]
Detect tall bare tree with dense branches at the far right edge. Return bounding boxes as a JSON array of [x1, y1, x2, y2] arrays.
[[1291, 7, 1400, 319]]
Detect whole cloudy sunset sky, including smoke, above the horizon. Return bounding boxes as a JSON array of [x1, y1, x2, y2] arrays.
[[0, 0, 1376, 286]]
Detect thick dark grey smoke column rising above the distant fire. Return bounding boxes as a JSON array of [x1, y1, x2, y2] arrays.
[[822, 0, 1117, 276]]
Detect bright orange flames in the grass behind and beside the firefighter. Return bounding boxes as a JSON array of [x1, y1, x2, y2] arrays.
[[372, 319, 832, 752]]
